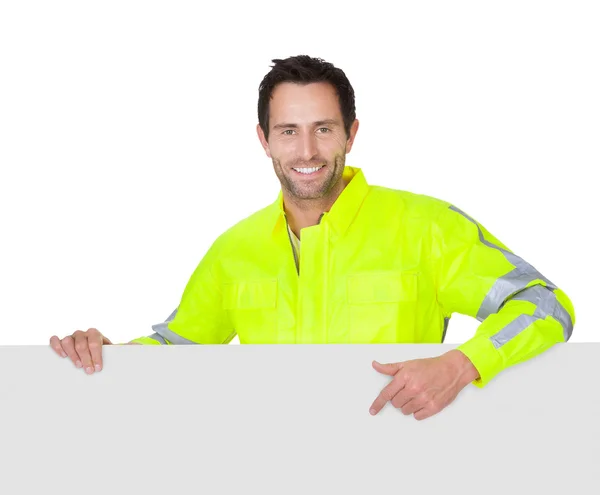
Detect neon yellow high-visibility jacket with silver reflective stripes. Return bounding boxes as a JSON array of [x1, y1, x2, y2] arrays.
[[132, 166, 575, 387]]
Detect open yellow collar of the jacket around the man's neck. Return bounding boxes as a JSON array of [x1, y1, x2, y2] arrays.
[[271, 166, 369, 241]]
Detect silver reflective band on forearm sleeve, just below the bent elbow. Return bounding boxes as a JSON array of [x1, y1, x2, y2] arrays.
[[490, 285, 573, 349]]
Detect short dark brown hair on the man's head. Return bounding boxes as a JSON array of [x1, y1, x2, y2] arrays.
[[258, 55, 356, 139]]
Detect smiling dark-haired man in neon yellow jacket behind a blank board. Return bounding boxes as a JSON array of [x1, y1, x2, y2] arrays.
[[50, 55, 575, 419]]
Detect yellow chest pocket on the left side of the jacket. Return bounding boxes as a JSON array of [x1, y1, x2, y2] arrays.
[[223, 279, 278, 344]]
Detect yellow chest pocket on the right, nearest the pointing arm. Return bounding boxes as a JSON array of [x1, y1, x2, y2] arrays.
[[347, 270, 419, 344]]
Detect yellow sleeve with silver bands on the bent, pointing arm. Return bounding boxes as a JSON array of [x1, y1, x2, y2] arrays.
[[433, 204, 575, 387]]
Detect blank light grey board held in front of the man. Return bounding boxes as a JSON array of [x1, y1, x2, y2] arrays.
[[0, 343, 600, 495]]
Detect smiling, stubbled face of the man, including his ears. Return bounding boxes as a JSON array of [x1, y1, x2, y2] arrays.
[[258, 83, 358, 200]]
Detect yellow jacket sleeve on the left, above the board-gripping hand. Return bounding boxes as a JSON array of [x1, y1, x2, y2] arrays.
[[130, 241, 236, 345]]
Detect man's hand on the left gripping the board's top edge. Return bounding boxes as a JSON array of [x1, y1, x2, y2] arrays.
[[50, 328, 139, 375]]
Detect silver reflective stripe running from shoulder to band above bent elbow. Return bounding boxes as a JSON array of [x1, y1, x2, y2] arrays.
[[449, 205, 556, 321]]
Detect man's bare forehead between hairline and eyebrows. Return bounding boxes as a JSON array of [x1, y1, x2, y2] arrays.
[[269, 82, 341, 125]]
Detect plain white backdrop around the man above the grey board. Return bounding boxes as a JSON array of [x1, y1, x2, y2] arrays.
[[0, 0, 600, 345]]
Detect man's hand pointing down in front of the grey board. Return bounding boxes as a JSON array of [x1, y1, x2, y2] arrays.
[[369, 349, 479, 420]]
